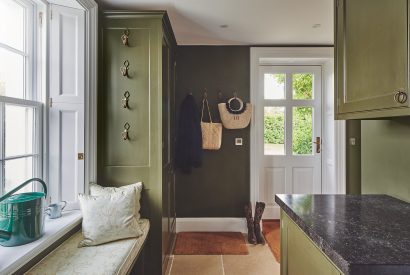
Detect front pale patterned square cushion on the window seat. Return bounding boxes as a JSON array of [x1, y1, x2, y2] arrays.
[[78, 189, 142, 247]]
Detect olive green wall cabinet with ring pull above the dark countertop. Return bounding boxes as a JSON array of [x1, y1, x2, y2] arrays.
[[335, 0, 410, 119]]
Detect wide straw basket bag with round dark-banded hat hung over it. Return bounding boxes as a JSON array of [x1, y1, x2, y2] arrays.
[[218, 97, 252, 129]]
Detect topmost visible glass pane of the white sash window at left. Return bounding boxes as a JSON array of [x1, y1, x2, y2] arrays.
[[0, 0, 25, 51]]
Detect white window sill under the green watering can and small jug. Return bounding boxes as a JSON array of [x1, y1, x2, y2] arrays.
[[0, 210, 82, 274]]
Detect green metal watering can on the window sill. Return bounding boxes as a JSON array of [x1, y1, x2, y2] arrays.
[[0, 178, 47, 246]]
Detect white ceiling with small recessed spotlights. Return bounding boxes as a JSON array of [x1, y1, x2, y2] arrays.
[[98, 0, 333, 45]]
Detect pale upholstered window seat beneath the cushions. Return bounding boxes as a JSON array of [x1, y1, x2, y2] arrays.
[[26, 219, 150, 275]]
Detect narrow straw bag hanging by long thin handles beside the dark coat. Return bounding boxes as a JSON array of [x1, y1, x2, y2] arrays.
[[201, 99, 222, 150]]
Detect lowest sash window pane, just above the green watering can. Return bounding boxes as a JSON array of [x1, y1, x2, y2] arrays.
[[5, 157, 34, 193]]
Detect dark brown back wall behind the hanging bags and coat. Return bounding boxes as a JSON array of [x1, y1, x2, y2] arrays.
[[176, 46, 250, 217]]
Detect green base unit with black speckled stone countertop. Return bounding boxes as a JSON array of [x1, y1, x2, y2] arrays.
[[275, 195, 410, 275]]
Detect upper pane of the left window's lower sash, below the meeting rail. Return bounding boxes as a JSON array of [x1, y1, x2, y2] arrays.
[[5, 104, 34, 157]]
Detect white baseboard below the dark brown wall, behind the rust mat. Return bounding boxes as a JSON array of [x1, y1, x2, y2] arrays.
[[176, 218, 248, 233]]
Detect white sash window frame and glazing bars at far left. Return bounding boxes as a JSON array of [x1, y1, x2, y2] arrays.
[[0, 0, 44, 195]]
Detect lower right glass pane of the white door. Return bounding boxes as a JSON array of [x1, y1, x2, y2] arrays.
[[292, 107, 313, 155]]
